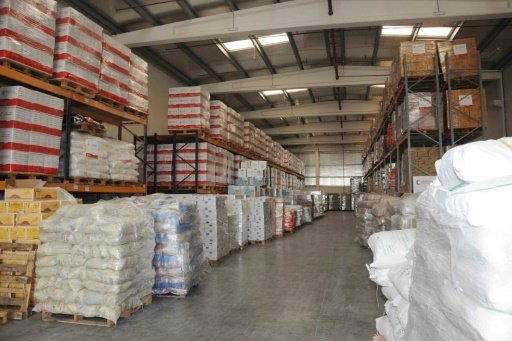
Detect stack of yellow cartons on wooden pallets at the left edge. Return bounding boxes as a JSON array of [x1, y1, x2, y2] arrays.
[[0, 187, 73, 245]]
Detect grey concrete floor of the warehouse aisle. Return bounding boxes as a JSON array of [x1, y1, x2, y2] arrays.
[[0, 212, 383, 341]]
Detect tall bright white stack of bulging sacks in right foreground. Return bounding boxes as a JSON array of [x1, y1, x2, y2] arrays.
[[404, 138, 512, 341]]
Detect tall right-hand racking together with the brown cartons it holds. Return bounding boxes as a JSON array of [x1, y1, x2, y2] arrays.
[[363, 40, 486, 193]]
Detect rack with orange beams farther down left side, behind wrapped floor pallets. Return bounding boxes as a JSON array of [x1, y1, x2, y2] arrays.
[[144, 130, 304, 193]]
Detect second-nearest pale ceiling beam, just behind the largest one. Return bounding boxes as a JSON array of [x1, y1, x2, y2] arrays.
[[204, 66, 390, 93]]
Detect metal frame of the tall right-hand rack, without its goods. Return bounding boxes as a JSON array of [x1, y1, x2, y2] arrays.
[[363, 54, 486, 193]]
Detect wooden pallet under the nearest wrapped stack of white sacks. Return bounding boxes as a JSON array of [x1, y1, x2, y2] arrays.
[[41, 295, 153, 327]]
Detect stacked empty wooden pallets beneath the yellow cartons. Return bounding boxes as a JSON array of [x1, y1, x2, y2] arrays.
[[0, 243, 36, 320]]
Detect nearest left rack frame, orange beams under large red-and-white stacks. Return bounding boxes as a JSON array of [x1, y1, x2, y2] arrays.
[[0, 65, 147, 194]]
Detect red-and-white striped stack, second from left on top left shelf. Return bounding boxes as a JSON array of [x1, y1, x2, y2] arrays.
[[53, 7, 103, 93]]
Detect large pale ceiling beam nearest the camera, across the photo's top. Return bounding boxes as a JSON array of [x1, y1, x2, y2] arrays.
[[117, 0, 512, 47]]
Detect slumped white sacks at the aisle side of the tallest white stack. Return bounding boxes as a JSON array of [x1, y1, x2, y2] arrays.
[[368, 229, 416, 341]]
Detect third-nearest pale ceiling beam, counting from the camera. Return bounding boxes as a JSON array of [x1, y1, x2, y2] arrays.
[[241, 101, 379, 120]]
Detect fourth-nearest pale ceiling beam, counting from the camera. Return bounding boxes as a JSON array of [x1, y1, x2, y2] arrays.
[[263, 120, 372, 136]]
